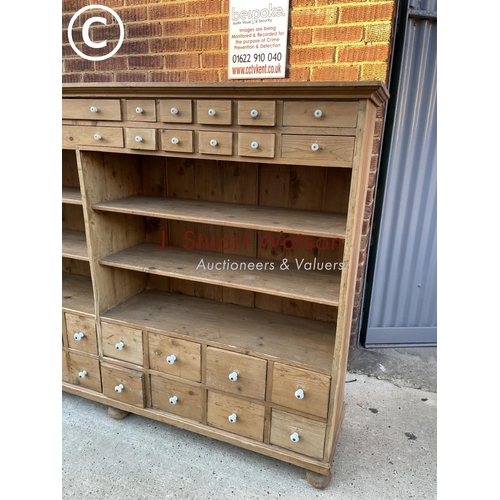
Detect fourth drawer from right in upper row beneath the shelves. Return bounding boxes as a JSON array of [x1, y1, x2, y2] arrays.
[[101, 322, 144, 366]]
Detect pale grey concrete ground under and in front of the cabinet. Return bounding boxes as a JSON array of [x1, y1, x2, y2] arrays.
[[62, 352, 437, 500]]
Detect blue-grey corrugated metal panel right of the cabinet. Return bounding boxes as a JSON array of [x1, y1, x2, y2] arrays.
[[364, 0, 437, 347]]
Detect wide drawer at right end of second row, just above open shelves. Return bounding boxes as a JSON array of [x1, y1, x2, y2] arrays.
[[281, 135, 354, 163]]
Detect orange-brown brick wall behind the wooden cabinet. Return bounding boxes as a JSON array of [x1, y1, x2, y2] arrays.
[[62, 0, 396, 336]]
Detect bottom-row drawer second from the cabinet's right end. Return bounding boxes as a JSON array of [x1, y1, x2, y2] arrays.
[[207, 391, 265, 441]]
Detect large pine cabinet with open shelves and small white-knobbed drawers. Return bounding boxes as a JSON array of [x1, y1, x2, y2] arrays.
[[62, 82, 387, 486]]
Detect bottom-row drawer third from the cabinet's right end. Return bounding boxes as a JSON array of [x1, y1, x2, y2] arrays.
[[151, 375, 205, 422]]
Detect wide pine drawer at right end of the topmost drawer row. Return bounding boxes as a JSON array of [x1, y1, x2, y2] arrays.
[[283, 101, 358, 128]]
